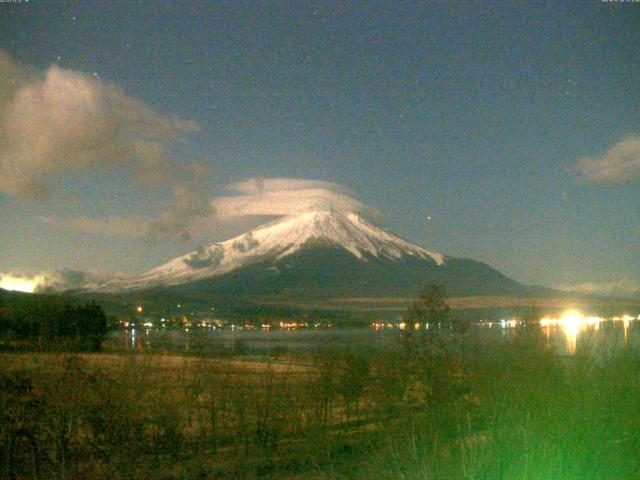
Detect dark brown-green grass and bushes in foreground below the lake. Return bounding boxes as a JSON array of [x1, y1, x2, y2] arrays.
[[0, 324, 640, 479]]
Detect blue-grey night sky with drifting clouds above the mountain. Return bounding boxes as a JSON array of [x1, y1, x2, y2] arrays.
[[0, 0, 640, 289]]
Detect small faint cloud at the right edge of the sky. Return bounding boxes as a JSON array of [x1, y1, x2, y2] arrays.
[[574, 136, 640, 183]]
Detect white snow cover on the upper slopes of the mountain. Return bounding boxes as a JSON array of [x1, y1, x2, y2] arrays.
[[99, 210, 444, 292]]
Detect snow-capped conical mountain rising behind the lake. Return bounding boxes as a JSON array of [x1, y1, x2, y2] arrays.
[[94, 210, 542, 298]]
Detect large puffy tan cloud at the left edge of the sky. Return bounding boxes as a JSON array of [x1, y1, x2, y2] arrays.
[[0, 50, 199, 198]]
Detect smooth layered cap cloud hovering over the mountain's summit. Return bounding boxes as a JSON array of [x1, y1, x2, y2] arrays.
[[211, 178, 379, 220]]
